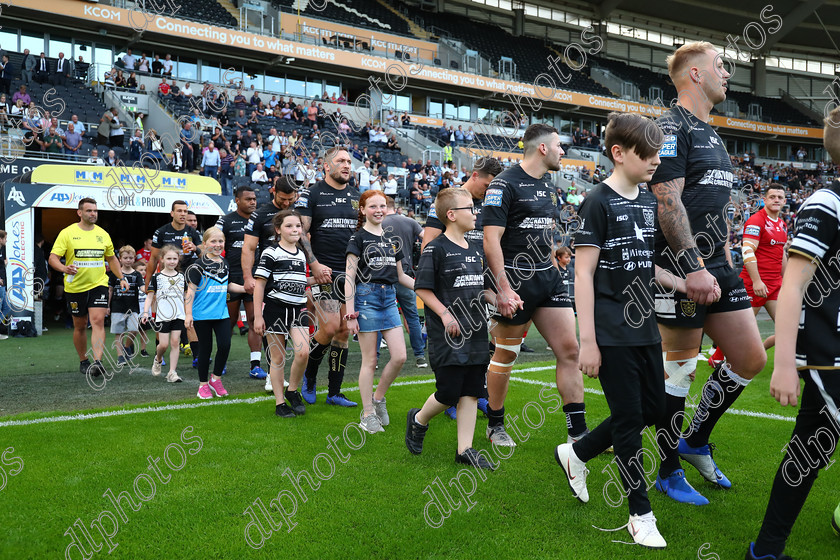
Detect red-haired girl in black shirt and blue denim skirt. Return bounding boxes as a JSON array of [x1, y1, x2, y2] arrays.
[[344, 190, 414, 434]]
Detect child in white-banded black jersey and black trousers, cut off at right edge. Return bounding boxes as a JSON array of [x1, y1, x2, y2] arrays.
[[746, 108, 840, 560]]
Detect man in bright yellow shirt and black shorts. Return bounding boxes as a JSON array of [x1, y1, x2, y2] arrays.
[[49, 198, 129, 377]]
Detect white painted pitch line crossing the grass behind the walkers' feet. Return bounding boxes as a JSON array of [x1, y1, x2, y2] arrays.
[[0, 366, 796, 428]]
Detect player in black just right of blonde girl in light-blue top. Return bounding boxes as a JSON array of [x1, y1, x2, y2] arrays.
[[216, 185, 266, 379]]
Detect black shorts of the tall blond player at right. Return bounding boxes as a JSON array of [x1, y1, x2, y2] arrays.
[[655, 263, 752, 329]]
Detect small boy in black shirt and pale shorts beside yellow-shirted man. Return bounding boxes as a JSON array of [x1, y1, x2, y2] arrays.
[[108, 245, 146, 364]]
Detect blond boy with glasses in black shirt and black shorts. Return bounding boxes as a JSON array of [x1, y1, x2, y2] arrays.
[[405, 189, 495, 470]]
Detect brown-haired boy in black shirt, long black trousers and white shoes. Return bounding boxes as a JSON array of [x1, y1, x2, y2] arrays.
[[554, 113, 684, 548]]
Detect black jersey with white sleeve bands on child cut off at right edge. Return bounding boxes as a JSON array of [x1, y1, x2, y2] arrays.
[[789, 181, 840, 370]]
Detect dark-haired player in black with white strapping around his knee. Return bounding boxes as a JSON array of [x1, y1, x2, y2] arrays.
[[482, 124, 586, 447]]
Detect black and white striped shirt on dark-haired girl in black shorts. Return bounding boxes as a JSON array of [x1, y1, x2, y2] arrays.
[[254, 245, 306, 306]]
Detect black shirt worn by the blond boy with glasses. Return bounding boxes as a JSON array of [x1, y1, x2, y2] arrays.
[[414, 235, 490, 368]]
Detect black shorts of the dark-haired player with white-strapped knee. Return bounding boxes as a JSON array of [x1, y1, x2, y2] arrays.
[[490, 267, 572, 325]]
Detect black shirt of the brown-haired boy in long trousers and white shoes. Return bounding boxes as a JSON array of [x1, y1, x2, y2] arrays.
[[575, 183, 661, 346]]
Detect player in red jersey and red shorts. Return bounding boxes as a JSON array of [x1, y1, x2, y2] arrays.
[[741, 183, 788, 350]]
